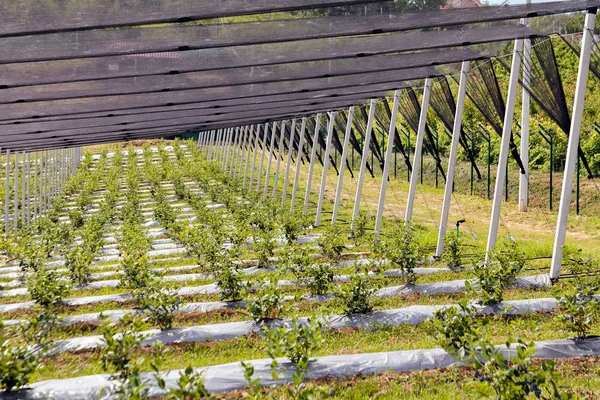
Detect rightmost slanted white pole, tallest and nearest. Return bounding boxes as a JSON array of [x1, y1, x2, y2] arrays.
[[550, 8, 597, 279]]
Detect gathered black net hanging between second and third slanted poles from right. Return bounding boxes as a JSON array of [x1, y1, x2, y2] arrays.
[[467, 60, 525, 173]]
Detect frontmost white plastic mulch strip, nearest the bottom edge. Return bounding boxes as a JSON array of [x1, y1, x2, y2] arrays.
[[11, 339, 600, 400]]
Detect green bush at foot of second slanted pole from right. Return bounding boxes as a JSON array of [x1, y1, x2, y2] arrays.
[[467, 242, 527, 305]]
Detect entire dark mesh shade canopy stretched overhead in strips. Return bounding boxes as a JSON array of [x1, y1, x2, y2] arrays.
[[0, 0, 600, 150]]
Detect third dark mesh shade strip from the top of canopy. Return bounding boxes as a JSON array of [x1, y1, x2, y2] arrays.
[[0, 25, 536, 88]]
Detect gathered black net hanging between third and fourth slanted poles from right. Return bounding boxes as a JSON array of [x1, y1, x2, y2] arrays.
[[430, 77, 481, 179]]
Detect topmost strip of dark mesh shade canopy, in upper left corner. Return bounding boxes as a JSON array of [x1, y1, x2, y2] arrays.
[[0, 0, 381, 37]]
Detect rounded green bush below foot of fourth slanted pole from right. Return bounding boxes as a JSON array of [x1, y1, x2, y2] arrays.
[[374, 223, 423, 285]]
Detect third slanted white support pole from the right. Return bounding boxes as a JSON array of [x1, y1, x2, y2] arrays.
[[434, 61, 474, 260]]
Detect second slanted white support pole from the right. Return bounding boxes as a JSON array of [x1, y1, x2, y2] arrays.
[[485, 39, 523, 263]]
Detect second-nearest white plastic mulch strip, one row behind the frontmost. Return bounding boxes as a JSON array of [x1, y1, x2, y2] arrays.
[[45, 299, 557, 354]]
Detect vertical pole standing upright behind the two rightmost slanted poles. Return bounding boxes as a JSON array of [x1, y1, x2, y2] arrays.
[[519, 19, 531, 212]]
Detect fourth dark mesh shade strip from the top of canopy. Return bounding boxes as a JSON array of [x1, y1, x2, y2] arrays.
[[0, 48, 482, 104]]
